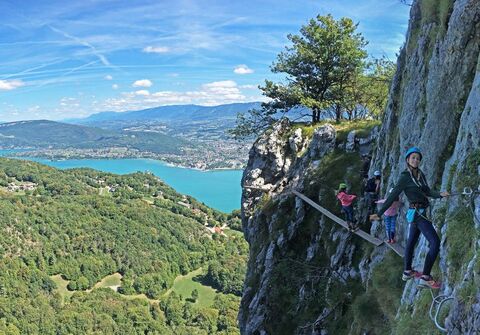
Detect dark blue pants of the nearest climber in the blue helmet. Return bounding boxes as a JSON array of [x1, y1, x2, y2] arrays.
[[405, 214, 440, 275]]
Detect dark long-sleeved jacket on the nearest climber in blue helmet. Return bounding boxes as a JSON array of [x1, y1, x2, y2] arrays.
[[377, 169, 442, 216]]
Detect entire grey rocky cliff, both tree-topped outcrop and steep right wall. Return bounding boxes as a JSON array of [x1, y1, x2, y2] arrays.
[[239, 0, 480, 334]]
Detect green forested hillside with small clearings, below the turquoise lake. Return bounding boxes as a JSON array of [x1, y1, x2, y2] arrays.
[[0, 159, 247, 334]]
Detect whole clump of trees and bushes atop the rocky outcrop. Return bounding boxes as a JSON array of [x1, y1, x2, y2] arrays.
[[230, 15, 395, 138]]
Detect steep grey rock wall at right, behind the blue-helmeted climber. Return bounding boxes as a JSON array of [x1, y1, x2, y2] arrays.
[[374, 0, 480, 334]]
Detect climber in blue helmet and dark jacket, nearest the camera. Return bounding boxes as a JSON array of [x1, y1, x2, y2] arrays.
[[370, 147, 450, 289]]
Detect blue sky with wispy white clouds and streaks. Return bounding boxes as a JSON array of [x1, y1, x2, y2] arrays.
[[0, 0, 410, 122]]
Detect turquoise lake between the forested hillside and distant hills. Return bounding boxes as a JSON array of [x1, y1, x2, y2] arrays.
[[0, 150, 243, 213]]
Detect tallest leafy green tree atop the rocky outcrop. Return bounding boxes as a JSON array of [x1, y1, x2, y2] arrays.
[[232, 15, 367, 138]]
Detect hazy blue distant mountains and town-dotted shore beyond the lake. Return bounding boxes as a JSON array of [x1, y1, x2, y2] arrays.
[[0, 102, 308, 169]]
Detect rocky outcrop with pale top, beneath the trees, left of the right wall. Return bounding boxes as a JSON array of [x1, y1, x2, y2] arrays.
[[239, 119, 380, 334]]
